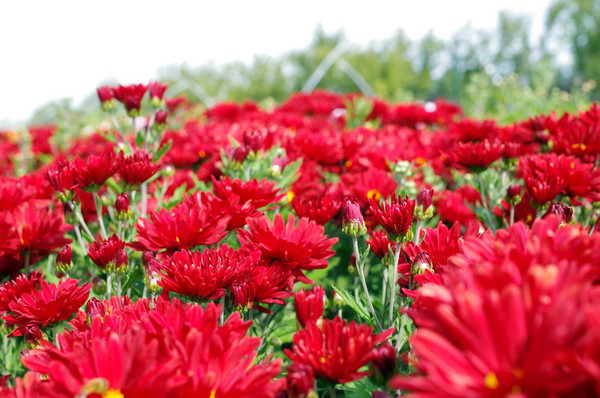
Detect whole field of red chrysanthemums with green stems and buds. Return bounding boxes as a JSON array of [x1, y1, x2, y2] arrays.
[[0, 82, 600, 398]]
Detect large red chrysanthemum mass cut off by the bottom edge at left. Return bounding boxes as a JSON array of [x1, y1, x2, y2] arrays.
[[23, 297, 285, 398]]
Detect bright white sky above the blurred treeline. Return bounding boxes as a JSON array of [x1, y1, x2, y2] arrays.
[[0, 0, 550, 128]]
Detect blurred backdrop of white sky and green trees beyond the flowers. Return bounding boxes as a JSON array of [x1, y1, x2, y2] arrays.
[[0, 0, 600, 129]]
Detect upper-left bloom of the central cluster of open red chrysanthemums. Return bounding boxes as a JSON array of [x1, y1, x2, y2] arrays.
[[129, 205, 229, 251]]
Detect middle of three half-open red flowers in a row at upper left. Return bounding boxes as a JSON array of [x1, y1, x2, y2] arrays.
[[73, 149, 117, 191]]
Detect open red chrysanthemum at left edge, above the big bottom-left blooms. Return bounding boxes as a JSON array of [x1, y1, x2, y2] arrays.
[[2, 279, 92, 337]]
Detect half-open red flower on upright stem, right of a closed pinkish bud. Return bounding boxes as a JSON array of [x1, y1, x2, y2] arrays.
[[369, 196, 415, 240]]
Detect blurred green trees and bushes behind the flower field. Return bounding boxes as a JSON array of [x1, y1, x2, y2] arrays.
[[32, 0, 600, 124]]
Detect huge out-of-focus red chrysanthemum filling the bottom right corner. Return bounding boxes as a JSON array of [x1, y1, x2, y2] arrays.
[[392, 216, 600, 397]]
